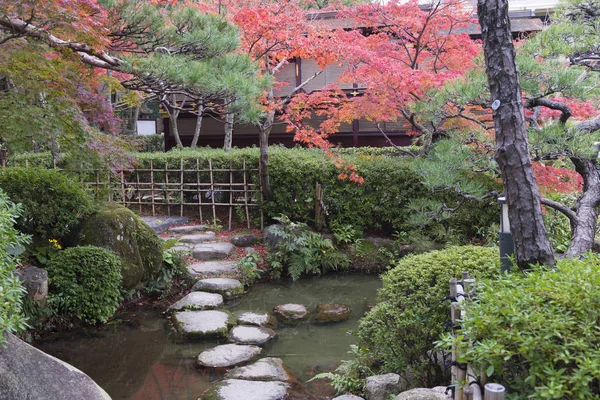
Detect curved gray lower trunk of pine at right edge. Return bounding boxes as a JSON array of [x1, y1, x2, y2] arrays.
[[565, 157, 600, 257]]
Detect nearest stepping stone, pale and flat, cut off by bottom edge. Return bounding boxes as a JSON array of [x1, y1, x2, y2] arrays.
[[202, 379, 290, 400]]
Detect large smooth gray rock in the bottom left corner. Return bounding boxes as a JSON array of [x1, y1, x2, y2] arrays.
[[0, 333, 110, 400]]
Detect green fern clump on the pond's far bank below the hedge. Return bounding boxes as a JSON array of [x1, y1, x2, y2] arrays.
[[267, 215, 350, 280]]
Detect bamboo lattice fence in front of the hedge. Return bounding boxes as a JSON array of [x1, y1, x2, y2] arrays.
[[10, 158, 264, 230]]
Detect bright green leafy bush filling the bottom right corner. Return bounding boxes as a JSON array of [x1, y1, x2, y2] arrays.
[[455, 254, 600, 399]]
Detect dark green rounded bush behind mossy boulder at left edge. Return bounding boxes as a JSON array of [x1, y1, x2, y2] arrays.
[[0, 168, 93, 238]]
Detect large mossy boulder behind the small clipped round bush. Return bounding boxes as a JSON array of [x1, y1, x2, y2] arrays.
[[68, 207, 162, 289]]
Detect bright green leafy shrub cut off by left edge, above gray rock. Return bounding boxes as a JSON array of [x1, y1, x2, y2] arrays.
[[0, 190, 27, 346]]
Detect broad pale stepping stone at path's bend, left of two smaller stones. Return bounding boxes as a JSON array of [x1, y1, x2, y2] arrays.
[[172, 310, 236, 339]]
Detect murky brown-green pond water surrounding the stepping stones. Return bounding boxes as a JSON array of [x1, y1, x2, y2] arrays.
[[35, 275, 381, 400]]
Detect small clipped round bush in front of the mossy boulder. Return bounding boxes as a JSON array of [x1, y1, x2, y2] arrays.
[[48, 246, 122, 324]]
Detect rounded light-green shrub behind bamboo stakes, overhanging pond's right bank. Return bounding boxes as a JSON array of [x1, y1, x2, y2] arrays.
[[358, 246, 500, 387]]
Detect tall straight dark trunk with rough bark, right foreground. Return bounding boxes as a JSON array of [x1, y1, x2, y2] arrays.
[[477, 0, 556, 268]]
